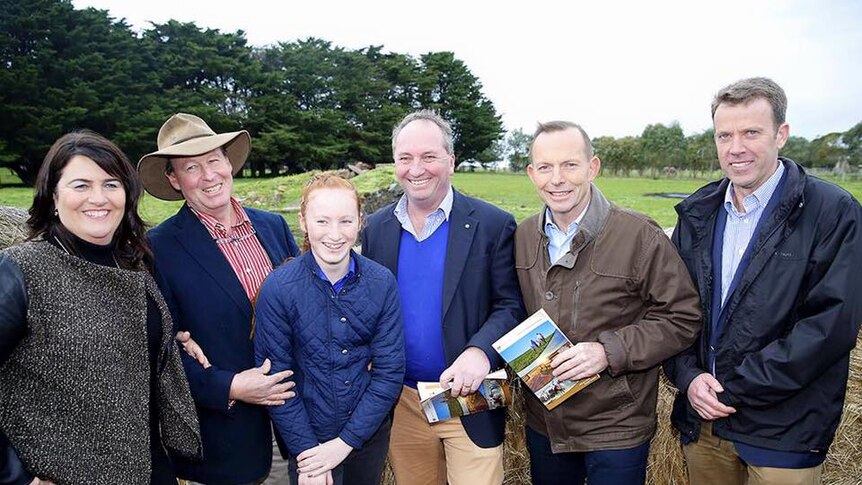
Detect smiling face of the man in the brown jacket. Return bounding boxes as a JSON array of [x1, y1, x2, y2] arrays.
[[527, 128, 601, 230]]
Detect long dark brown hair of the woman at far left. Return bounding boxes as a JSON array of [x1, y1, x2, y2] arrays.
[[27, 130, 153, 270]]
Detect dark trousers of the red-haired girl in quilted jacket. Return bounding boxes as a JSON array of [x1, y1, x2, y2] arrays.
[[288, 418, 392, 485]]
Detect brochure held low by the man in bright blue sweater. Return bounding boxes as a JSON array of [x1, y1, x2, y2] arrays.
[[416, 369, 512, 423]]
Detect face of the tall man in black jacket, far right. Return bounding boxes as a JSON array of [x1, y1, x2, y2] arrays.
[[713, 98, 790, 203]]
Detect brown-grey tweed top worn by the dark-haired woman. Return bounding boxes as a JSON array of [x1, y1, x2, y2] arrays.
[[0, 241, 201, 485]]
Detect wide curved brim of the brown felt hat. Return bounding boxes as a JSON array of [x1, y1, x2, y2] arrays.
[[138, 130, 251, 200]]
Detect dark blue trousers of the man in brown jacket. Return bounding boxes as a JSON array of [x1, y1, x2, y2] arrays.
[[527, 426, 649, 485]]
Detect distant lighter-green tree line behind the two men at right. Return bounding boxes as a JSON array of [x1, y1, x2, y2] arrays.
[[495, 122, 862, 176]]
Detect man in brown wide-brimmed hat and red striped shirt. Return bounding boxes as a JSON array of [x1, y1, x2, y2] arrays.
[[138, 113, 299, 485]]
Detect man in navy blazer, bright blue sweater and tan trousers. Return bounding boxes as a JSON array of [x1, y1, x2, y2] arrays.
[[362, 110, 524, 485]]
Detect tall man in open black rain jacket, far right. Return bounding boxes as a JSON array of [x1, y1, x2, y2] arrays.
[[665, 78, 862, 485]]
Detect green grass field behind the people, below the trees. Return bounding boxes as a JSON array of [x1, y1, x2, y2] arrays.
[[0, 165, 862, 231]]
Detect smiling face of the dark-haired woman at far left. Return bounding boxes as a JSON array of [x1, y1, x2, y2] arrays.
[[54, 155, 126, 245]]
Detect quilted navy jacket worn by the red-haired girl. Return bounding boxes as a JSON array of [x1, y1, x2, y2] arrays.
[[254, 252, 404, 456]]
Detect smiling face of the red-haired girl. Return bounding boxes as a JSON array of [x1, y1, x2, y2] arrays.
[[299, 188, 360, 279]]
